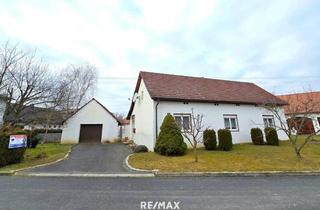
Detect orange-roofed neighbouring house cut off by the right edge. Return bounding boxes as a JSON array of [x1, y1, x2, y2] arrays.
[[278, 91, 320, 134]]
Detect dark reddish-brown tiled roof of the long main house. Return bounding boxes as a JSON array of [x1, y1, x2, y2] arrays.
[[129, 71, 286, 116]]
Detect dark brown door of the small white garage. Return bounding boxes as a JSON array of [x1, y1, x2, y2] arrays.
[[79, 124, 102, 143]]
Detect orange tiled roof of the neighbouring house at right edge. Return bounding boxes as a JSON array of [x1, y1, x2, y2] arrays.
[[278, 91, 320, 114]]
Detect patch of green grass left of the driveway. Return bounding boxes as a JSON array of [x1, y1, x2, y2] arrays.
[[0, 143, 71, 172]]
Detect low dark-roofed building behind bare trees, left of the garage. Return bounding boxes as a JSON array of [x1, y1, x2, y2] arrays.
[[8, 105, 65, 130]]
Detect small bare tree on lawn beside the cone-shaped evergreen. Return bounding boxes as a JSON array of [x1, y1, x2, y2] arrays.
[[182, 109, 204, 162]]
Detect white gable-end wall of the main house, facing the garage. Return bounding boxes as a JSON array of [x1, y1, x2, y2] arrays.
[[130, 80, 155, 151]]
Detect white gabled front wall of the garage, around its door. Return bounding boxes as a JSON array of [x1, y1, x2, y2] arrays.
[[61, 100, 119, 144]]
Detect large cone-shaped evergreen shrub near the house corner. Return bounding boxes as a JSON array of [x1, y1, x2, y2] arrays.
[[154, 114, 187, 156]]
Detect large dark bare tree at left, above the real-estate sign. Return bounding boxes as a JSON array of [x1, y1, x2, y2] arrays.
[[4, 53, 52, 125]]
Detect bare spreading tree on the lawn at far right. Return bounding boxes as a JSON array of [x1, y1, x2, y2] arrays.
[[264, 91, 320, 159]]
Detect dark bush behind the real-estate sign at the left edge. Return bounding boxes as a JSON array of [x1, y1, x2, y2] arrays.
[[0, 130, 26, 167]]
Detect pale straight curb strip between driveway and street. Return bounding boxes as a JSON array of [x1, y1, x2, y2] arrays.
[[17, 173, 155, 178]]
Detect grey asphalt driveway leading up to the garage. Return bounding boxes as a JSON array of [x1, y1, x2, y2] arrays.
[[23, 143, 133, 174]]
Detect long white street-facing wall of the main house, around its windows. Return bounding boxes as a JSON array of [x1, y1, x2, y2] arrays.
[[158, 102, 287, 147]]
